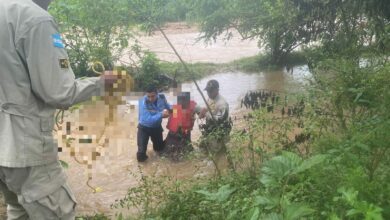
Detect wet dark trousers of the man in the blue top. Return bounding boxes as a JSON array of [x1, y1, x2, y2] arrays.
[[137, 124, 164, 158]]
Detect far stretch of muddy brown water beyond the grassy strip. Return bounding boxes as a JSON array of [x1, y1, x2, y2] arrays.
[[121, 23, 262, 63]]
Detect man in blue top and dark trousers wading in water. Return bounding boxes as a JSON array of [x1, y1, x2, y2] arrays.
[[137, 86, 172, 162]]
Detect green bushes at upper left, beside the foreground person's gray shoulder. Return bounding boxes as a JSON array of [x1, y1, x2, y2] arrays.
[[49, 0, 193, 77]]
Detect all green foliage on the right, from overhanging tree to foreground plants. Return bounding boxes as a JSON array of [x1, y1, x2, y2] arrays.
[[107, 0, 390, 219]]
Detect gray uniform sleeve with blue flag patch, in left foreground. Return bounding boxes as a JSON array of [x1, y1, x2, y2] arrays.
[[17, 20, 103, 108]]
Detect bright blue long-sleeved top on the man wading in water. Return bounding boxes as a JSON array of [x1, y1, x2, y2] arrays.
[[138, 94, 172, 128]]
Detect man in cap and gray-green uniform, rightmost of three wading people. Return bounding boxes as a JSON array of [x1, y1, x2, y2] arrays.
[[195, 79, 232, 151]]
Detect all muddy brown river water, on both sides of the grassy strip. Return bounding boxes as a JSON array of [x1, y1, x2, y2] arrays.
[[0, 23, 309, 216]]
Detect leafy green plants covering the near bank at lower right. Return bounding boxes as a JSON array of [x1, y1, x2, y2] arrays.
[[113, 54, 390, 219]]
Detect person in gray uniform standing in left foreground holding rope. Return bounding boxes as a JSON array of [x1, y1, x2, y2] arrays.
[[0, 0, 115, 220]]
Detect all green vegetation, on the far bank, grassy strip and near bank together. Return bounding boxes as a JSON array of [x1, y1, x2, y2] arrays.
[[46, 0, 390, 220]]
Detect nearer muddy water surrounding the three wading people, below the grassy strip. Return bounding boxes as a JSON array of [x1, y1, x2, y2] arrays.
[[58, 66, 310, 217]]
